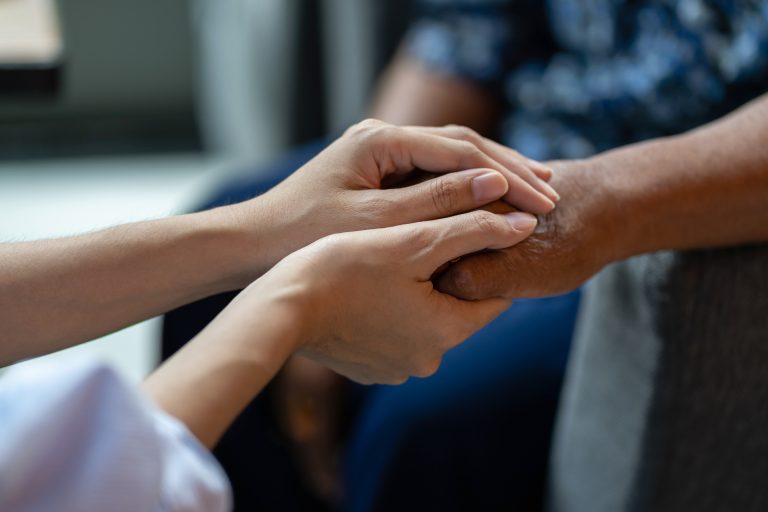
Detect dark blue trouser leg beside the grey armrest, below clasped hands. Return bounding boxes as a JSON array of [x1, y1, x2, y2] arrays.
[[344, 292, 579, 512]]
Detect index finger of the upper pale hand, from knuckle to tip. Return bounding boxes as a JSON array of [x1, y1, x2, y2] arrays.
[[374, 126, 555, 215]]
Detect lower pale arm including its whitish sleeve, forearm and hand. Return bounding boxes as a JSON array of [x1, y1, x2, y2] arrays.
[[0, 205, 535, 512]]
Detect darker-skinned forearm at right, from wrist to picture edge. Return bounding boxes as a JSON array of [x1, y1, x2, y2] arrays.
[[586, 93, 768, 260]]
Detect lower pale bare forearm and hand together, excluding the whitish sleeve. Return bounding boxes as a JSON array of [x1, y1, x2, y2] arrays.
[[144, 211, 536, 447]]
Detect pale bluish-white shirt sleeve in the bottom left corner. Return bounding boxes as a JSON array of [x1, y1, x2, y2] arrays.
[[0, 360, 232, 512]]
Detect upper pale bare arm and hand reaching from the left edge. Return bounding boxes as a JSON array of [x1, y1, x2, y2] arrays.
[[0, 121, 557, 365]]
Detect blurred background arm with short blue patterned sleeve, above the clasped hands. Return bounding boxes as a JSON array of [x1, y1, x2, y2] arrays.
[[371, 0, 554, 135]]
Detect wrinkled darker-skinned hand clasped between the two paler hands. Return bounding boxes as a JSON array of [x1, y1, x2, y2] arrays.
[[437, 161, 620, 300]]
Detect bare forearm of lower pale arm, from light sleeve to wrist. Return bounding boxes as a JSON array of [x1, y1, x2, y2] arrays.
[[144, 282, 301, 447]]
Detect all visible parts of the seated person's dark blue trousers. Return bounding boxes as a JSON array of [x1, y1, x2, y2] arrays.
[[163, 143, 579, 511]]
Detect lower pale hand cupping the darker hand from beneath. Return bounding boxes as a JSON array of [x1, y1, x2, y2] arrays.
[[249, 211, 536, 384]]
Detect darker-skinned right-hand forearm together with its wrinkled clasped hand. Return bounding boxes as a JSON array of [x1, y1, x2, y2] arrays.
[[439, 96, 768, 298]]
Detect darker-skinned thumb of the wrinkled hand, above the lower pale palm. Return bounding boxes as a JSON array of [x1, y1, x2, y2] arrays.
[[435, 251, 519, 300]]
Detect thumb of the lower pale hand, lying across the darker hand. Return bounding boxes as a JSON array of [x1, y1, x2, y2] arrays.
[[403, 210, 536, 279]]
